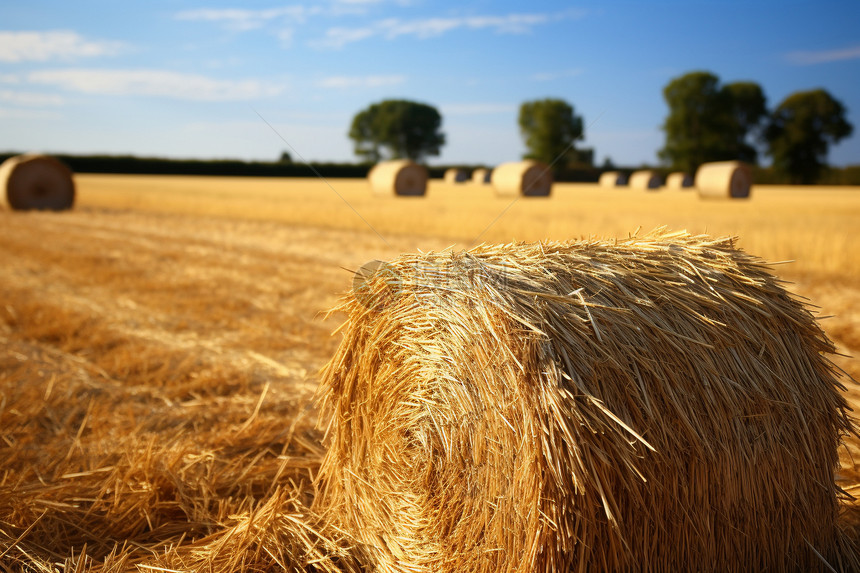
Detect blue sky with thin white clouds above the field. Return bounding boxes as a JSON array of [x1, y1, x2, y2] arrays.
[[0, 0, 860, 166]]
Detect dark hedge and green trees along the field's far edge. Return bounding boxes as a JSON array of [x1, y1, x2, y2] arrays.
[[0, 71, 848, 185]]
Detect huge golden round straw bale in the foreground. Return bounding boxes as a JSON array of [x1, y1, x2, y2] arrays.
[[314, 233, 858, 572]]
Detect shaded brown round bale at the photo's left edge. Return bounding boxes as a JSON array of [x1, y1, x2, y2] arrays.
[[0, 153, 75, 211]]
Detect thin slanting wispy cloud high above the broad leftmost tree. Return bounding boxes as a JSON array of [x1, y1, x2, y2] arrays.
[[313, 10, 564, 48]]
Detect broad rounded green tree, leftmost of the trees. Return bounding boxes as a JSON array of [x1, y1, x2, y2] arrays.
[[349, 100, 445, 163]]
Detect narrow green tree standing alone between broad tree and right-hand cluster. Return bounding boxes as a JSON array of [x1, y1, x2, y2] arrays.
[[519, 98, 593, 165]]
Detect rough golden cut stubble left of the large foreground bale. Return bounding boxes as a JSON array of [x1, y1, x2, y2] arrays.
[[0, 212, 386, 572]]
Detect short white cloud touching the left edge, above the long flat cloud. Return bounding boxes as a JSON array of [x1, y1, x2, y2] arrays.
[[0, 30, 125, 63]]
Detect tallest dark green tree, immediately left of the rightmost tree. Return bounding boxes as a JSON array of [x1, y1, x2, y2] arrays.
[[659, 71, 767, 173]]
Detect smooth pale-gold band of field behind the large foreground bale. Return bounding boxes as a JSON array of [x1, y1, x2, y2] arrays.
[[77, 175, 860, 277]]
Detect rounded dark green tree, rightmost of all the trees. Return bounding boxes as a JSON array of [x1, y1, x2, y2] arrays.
[[764, 89, 854, 184]]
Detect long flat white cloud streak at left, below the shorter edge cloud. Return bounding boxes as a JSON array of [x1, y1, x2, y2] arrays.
[[27, 68, 284, 101]]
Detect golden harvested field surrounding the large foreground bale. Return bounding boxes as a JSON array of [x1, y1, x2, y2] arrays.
[[0, 175, 860, 571]]
